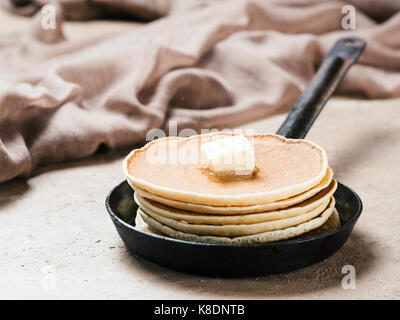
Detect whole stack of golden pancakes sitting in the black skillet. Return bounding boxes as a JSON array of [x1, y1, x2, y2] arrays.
[[124, 132, 339, 244]]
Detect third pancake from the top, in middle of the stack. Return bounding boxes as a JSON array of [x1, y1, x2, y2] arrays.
[[135, 181, 337, 225]]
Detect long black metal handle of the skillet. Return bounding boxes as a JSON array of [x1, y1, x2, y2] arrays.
[[277, 37, 366, 139]]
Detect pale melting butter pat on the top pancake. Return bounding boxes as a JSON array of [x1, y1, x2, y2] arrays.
[[200, 135, 255, 175]]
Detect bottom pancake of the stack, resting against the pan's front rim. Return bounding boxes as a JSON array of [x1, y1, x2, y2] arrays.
[[138, 201, 334, 245]]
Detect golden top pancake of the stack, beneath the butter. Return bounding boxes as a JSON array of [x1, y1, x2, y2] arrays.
[[124, 132, 327, 206]]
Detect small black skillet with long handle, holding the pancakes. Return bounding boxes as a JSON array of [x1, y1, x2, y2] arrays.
[[106, 38, 365, 277]]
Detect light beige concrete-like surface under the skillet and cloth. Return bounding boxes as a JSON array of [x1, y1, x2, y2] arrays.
[[0, 11, 400, 299]]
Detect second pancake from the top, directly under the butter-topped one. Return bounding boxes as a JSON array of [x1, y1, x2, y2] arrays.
[[134, 167, 337, 215]]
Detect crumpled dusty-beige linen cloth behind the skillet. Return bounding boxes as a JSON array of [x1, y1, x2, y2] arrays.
[[0, 0, 400, 182]]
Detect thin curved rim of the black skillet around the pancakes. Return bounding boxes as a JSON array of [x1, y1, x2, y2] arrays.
[[105, 180, 363, 249]]
